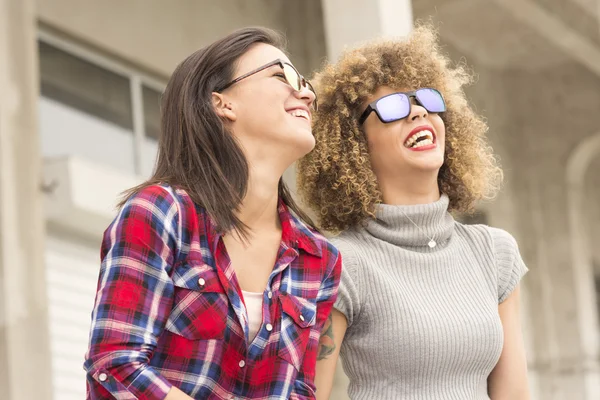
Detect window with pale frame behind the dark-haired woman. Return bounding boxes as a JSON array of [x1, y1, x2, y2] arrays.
[[39, 31, 164, 178]]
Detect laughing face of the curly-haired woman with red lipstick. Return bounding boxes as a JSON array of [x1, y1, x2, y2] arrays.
[[363, 86, 446, 181]]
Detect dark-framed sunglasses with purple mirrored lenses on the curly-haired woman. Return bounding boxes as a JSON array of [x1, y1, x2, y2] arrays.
[[358, 88, 446, 125]]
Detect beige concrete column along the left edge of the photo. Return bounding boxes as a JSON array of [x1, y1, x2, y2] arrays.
[[0, 0, 54, 400]]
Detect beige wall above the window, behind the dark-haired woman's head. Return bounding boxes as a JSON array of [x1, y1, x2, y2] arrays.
[[37, 0, 325, 76]]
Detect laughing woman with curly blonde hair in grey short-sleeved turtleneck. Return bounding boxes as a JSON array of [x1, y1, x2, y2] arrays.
[[298, 26, 529, 400]]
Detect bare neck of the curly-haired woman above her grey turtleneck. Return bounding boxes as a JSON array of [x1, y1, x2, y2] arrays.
[[378, 171, 440, 205]]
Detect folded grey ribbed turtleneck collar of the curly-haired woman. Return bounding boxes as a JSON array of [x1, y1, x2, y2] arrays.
[[365, 194, 454, 251]]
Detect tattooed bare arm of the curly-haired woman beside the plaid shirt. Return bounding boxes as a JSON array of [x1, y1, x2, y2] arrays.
[[315, 308, 348, 400]]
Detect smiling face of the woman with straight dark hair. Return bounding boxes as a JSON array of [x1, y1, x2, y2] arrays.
[[222, 43, 315, 168]]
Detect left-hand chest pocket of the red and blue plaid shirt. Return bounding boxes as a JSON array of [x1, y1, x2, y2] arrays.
[[165, 262, 229, 340]]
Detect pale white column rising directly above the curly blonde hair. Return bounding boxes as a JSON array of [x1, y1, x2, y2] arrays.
[[322, 0, 413, 61]]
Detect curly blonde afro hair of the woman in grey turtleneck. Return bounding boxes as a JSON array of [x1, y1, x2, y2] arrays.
[[297, 25, 502, 232]]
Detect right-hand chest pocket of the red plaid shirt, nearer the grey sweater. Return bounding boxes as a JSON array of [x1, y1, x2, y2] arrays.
[[277, 293, 317, 370]]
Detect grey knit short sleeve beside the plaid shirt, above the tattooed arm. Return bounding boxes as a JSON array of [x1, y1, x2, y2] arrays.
[[331, 238, 361, 327]]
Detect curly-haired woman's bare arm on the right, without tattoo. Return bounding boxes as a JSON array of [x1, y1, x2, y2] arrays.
[[488, 286, 530, 400]]
